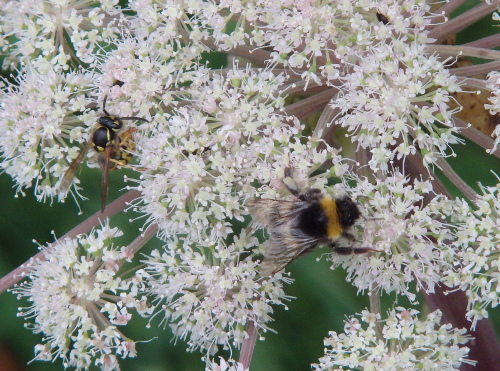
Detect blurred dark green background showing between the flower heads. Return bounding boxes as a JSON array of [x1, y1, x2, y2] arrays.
[[0, 2, 500, 371]]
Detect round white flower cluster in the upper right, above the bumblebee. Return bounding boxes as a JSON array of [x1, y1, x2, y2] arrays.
[[332, 40, 460, 171]]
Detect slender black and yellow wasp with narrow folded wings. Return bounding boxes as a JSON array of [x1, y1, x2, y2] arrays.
[[60, 96, 149, 212]]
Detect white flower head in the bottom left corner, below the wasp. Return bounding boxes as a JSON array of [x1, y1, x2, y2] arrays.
[[13, 225, 143, 370]]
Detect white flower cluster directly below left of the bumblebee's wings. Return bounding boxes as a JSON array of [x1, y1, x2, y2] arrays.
[[139, 238, 291, 353]]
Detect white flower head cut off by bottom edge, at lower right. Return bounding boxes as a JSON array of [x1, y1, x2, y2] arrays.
[[313, 307, 474, 371]]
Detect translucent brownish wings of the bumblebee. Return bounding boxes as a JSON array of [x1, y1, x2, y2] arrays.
[[247, 199, 320, 276]]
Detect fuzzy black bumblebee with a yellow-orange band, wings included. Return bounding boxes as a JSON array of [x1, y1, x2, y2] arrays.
[[247, 169, 378, 276]]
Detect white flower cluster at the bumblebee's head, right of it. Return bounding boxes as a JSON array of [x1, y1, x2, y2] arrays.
[[329, 172, 457, 300]]
